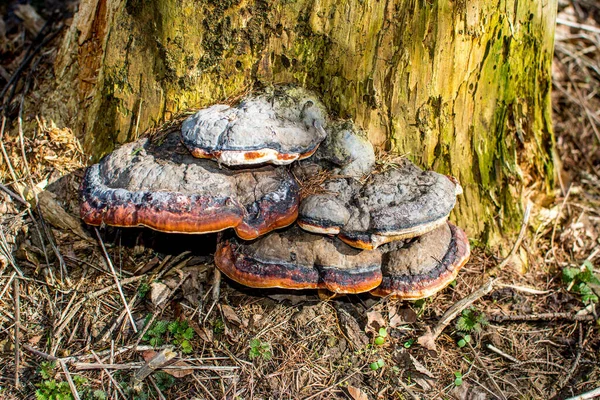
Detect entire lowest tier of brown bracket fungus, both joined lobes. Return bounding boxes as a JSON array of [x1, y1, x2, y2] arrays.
[[215, 223, 469, 300]]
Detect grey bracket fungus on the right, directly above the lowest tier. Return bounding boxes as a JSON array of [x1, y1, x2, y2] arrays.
[[297, 159, 461, 249]]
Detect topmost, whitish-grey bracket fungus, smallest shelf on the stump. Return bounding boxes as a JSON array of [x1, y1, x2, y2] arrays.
[[182, 86, 327, 166]]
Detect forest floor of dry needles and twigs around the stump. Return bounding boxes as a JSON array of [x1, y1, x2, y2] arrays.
[[0, 0, 600, 400]]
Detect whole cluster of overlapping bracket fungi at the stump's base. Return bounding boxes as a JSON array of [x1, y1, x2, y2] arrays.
[[81, 86, 469, 300]]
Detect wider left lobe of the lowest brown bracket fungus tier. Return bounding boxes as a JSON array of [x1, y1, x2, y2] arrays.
[[215, 226, 381, 293]]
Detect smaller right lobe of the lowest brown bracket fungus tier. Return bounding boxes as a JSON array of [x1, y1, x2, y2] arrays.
[[371, 223, 470, 300]]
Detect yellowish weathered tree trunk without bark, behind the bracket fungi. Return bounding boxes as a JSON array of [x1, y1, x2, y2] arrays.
[[45, 0, 557, 244]]
